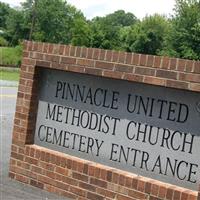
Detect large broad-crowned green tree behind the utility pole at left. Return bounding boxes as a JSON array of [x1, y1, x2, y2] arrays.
[[7, 0, 89, 46]]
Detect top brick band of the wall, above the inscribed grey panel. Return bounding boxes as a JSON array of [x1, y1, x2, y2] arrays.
[[21, 41, 200, 92]]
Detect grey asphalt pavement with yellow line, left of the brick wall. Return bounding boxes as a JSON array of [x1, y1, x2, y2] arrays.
[[0, 84, 69, 200]]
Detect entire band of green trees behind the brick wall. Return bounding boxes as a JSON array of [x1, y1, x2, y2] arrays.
[[0, 0, 200, 59]]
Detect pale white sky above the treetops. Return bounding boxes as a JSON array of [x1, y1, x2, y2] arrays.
[[0, 0, 175, 19]]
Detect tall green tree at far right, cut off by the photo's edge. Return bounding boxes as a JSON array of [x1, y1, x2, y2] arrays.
[[168, 0, 200, 59]]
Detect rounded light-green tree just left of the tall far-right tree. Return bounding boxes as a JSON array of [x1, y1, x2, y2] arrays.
[[126, 14, 170, 54]]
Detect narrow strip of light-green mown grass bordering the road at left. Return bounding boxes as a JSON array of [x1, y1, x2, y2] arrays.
[[0, 68, 19, 81]]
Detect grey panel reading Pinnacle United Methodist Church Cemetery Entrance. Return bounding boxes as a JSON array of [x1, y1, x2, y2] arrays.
[[34, 69, 200, 190]]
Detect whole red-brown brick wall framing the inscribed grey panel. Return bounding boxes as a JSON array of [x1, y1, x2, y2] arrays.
[[9, 41, 200, 200]]
